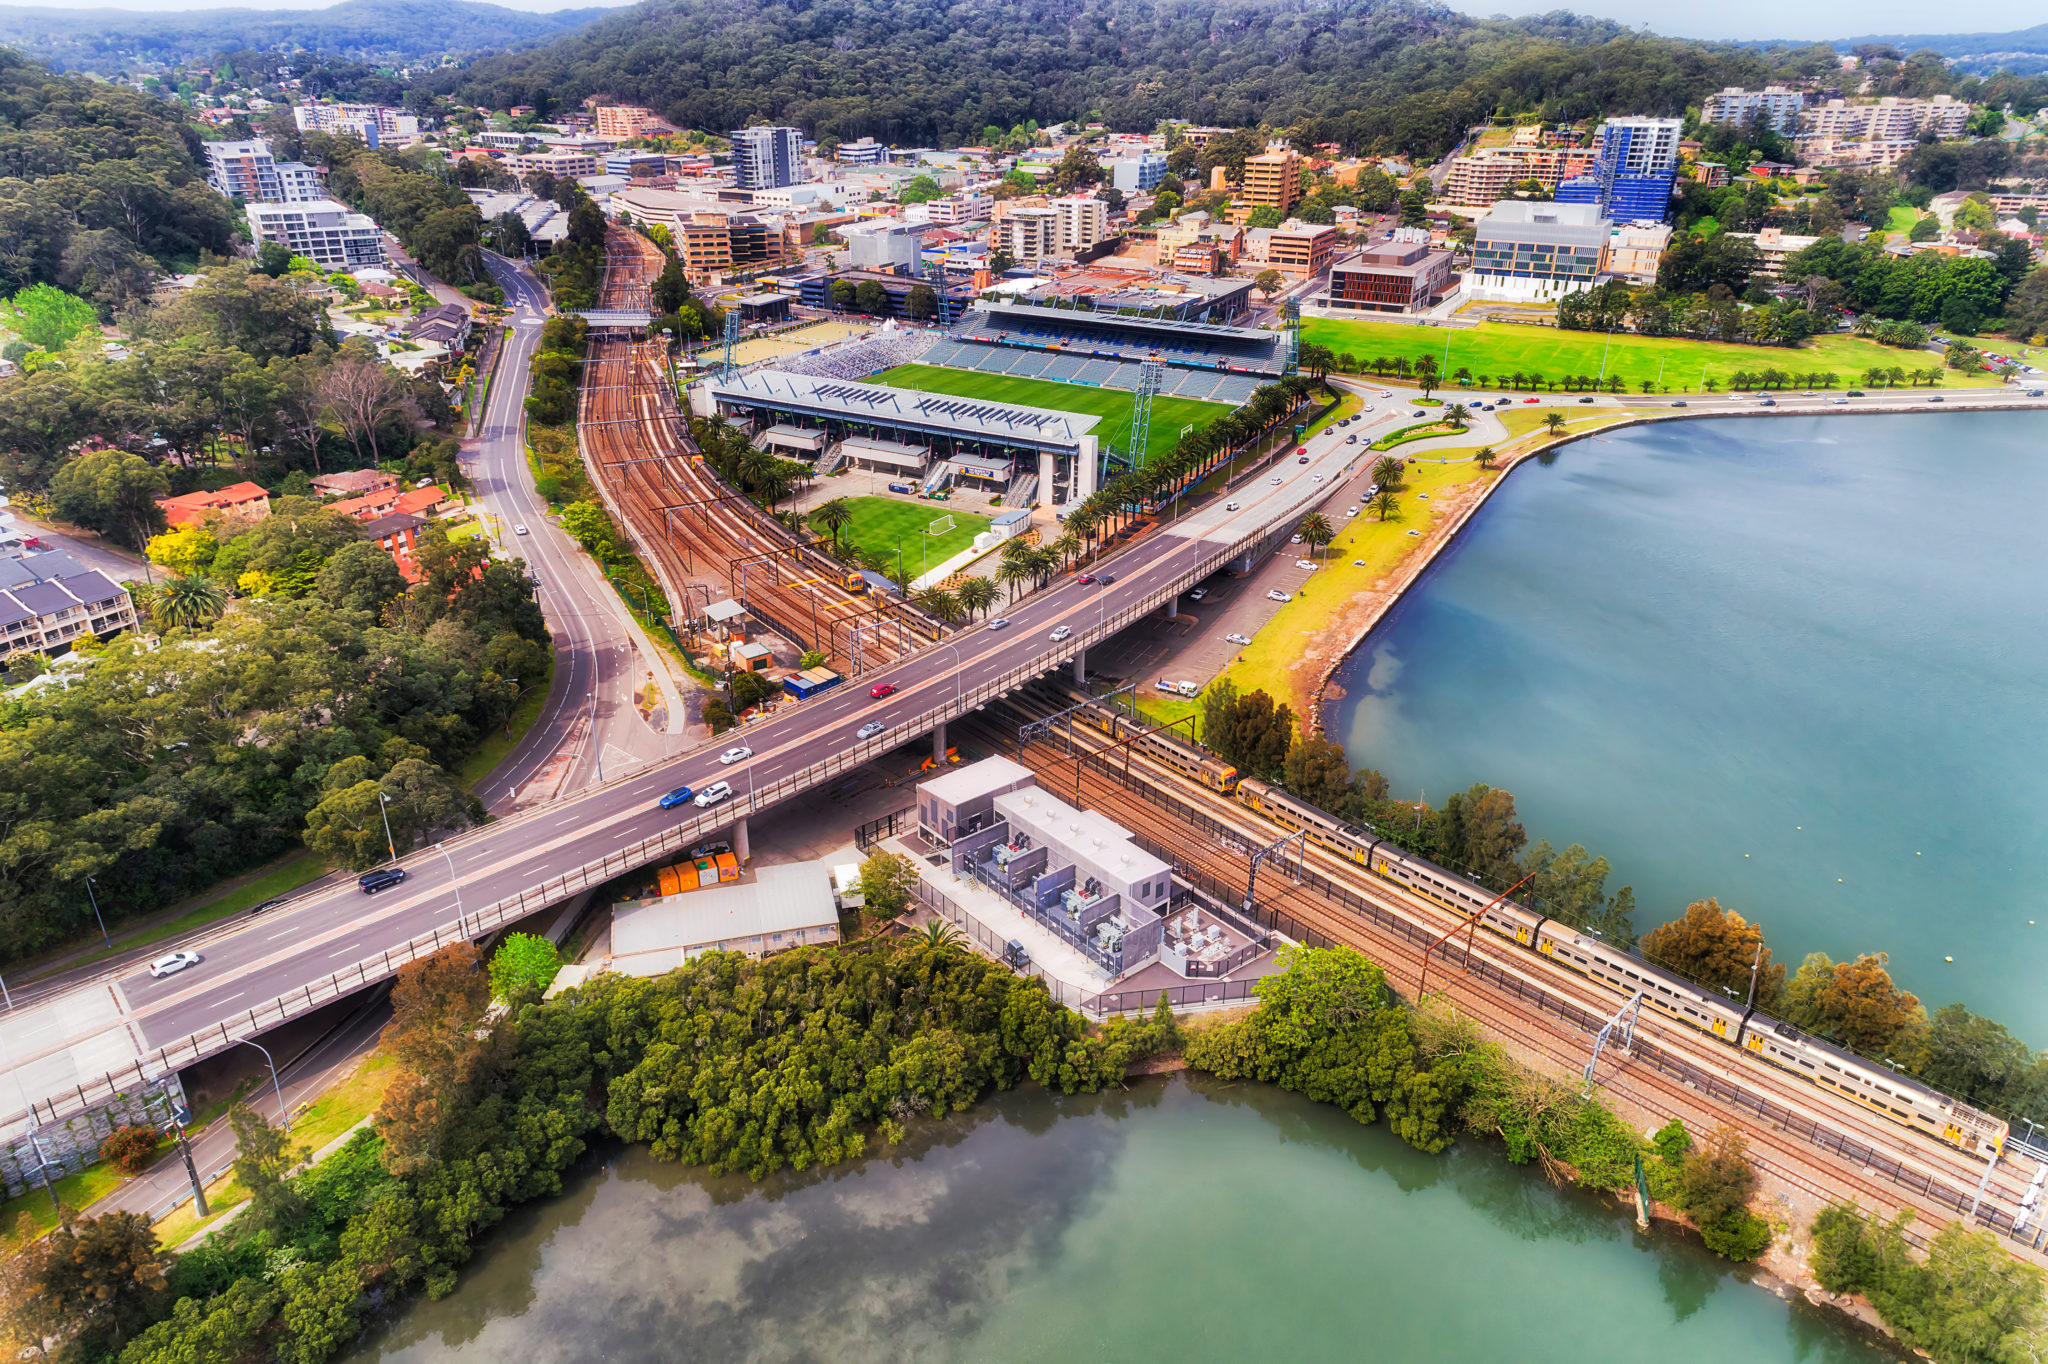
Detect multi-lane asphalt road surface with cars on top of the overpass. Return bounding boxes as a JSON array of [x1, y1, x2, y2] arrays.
[[0, 395, 1356, 1131]]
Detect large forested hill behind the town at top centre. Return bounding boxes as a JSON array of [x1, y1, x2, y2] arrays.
[[436, 0, 1835, 154]]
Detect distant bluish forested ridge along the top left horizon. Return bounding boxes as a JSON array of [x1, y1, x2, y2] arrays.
[[0, 0, 604, 72]]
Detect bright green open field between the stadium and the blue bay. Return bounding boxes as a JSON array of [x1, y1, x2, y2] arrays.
[[1300, 317, 1999, 393]]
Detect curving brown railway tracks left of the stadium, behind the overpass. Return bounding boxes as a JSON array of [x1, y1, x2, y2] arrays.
[[578, 227, 942, 676]]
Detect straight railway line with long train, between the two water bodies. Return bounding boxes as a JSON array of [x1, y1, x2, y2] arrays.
[[979, 696, 2042, 1262]]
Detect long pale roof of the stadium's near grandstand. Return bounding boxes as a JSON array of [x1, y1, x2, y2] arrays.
[[711, 369, 1102, 451]]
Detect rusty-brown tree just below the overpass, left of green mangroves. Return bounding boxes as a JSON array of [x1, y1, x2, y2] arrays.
[[377, 942, 510, 1174]]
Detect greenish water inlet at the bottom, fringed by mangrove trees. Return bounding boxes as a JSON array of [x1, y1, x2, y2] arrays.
[[354, 1079, 1894, 1364]]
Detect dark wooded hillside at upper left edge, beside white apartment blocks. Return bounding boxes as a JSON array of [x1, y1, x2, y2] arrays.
[[0, 49, 233, 313]]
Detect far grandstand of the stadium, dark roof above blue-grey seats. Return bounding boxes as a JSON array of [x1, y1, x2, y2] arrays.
[[924, 303, 1286, 406]]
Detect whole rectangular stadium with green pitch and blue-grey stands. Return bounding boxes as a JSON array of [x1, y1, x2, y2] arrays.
[[692, 303, 1290, 508]]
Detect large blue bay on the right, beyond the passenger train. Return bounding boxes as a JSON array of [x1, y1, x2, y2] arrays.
[[1331, 414, 2048, 1047]]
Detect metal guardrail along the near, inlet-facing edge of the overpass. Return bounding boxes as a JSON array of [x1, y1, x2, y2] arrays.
[[0, 528, 1270, 1141]]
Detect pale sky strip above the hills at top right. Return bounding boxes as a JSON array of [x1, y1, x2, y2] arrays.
[[1450, 0, 2007, 41]]
